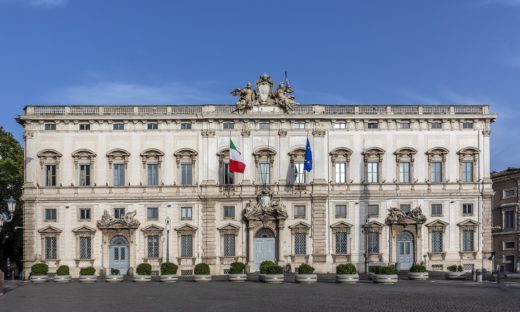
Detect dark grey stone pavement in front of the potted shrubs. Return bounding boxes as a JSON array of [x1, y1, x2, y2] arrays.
[[0, 280, 520, 312]]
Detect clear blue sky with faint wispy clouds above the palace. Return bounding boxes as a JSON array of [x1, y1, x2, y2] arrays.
[[0, 0, 520, 170]]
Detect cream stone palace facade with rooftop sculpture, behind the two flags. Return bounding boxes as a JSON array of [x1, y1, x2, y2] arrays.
[[18, 76, 496, 275]]
